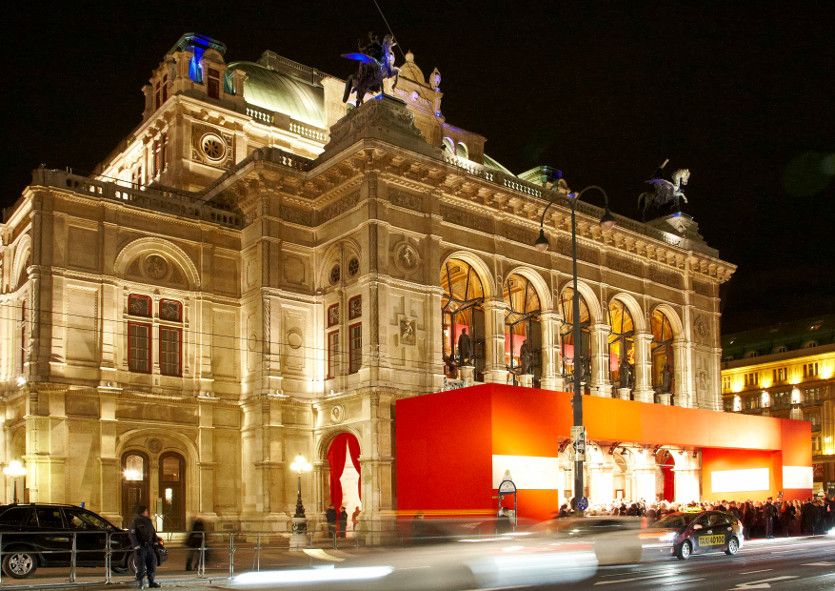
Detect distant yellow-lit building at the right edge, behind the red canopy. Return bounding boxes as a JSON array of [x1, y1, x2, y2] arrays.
[[722, 314, 835, 492]]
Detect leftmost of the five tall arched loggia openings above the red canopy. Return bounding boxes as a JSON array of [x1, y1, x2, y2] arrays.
[[441, 259, 484, 381]]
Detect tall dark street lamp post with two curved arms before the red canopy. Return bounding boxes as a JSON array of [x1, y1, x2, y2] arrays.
[[534, 182, 616, 515]]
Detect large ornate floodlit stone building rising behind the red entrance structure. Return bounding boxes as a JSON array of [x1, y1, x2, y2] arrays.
[[0, 36, 734, 530]]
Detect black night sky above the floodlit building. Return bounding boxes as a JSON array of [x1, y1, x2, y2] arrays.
[[0, 0, 835, 332]]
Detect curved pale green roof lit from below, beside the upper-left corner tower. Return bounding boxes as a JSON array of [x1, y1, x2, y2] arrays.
[[227, 62, 325, 127]]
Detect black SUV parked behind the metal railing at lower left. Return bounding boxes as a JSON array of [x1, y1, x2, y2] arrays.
[[0, 503, 160, 579]]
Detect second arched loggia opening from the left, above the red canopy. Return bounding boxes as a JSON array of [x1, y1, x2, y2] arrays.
[[504, 274, 542, 387]]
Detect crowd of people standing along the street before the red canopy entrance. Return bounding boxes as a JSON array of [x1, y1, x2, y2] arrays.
[[558, 497, 835, 538]]
